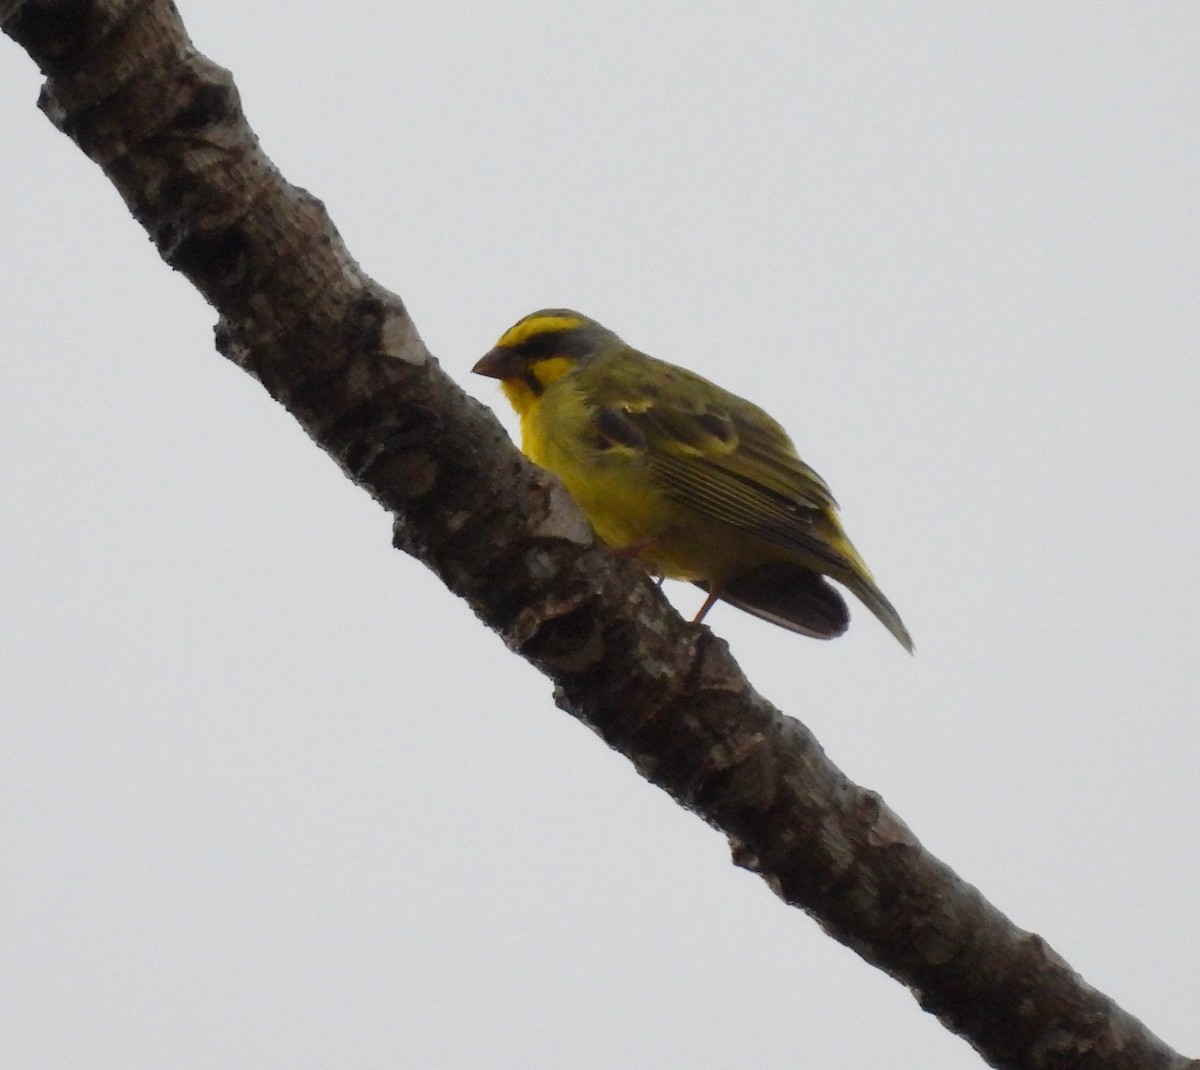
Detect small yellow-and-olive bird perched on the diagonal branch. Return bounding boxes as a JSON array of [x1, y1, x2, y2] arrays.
[[473, 308, 913, 653]]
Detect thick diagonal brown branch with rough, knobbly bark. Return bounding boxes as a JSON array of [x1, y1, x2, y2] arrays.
[[0, 0, 1200, 1070]]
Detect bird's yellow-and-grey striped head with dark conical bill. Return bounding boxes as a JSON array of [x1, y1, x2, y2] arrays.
[[472, 308, 622, 413]]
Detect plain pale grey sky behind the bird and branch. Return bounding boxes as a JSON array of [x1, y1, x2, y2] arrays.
[[0, 0, 1200, 1070]]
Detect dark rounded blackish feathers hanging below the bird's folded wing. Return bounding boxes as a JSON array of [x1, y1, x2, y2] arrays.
[[696, 561, 850, 639]]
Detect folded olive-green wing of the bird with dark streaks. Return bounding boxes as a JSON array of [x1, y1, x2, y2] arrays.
[[589, 354, 847, 569]]
